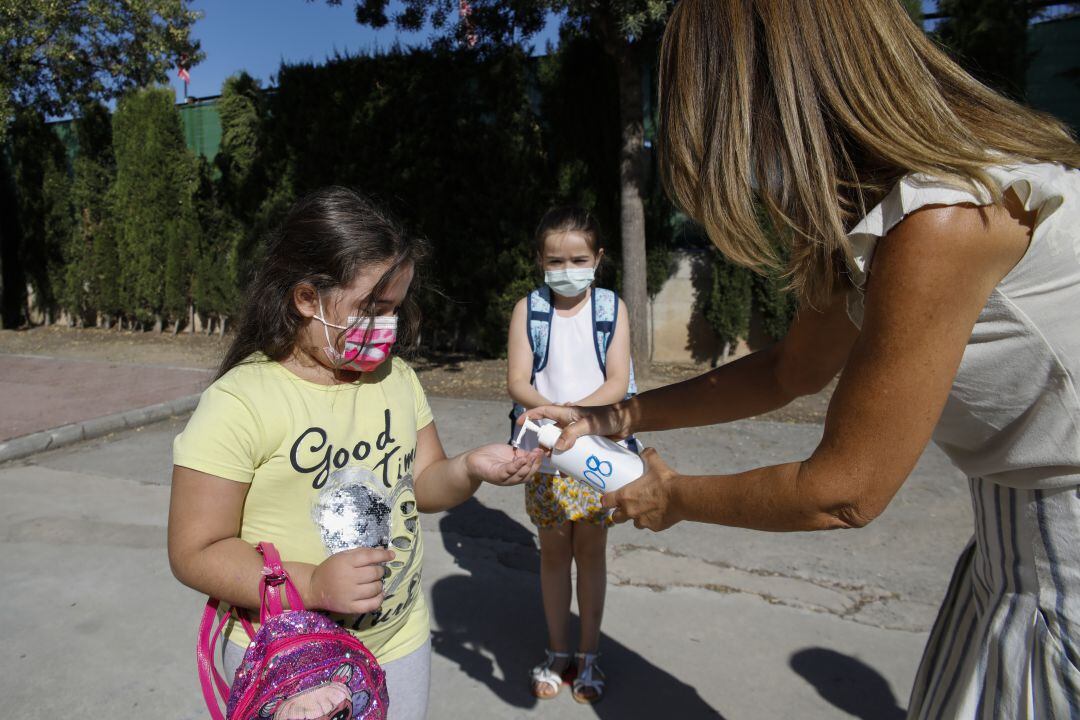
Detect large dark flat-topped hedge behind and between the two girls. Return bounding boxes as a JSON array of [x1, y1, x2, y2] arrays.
[[256, 47, 551, 354]]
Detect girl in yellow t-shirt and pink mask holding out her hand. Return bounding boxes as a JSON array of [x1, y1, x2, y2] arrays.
[[168, 188, 540, 720]]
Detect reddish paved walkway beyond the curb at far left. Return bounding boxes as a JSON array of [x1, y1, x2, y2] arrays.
[[0, 354, 214, 440]]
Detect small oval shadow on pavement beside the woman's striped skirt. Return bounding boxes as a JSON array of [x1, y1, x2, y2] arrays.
[[791, 648, 907, 720]]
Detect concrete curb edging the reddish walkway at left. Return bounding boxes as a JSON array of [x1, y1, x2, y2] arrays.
[[0, 395, 200, 464]]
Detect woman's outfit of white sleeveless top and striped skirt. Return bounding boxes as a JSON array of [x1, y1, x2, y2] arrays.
[[849, 163, 1080, 720]]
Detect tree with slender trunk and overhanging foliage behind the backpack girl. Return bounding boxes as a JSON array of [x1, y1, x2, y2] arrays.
[[327, 0, 675, 376]]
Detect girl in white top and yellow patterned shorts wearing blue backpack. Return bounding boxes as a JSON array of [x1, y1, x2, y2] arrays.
[[507, 207, 631, 703]]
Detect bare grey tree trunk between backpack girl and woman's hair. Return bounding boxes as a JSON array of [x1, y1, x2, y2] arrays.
[[616, 39, 651, 379]]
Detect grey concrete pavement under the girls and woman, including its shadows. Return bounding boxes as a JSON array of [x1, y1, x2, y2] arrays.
[[0, 398, 971, 720]]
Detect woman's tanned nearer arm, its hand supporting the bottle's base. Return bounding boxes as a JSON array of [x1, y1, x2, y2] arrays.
[[605, 199, 1029, 530]]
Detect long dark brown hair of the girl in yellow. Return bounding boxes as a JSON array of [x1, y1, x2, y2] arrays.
[[217, 186, 428, 378]]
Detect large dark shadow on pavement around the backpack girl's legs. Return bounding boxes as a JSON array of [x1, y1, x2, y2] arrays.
[[431, 499, 720, 719]]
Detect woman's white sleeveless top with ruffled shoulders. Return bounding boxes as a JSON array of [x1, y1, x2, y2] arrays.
[[848, 163, 1080, 489]]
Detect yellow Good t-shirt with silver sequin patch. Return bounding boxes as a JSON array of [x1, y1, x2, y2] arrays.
[[173, 355, 432, 663]]
